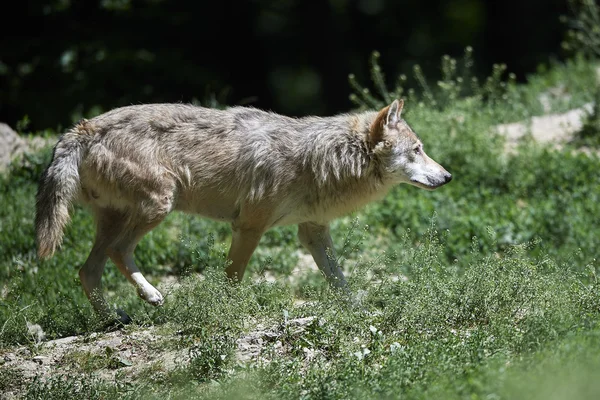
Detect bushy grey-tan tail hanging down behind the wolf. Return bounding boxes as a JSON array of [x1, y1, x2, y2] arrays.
[[35, 131, 83, 258]]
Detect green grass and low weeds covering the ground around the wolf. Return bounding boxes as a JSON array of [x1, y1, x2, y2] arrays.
[[0, 51, 600, 399]]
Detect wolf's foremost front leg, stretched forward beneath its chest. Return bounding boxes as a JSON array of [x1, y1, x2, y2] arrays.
[[298, 222, 347, 288]]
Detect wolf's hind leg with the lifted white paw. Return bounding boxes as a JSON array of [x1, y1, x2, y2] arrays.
[[108, 218, 164, 306]]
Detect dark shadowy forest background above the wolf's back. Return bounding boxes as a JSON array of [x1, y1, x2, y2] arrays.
[[0, 0, 569, 130]]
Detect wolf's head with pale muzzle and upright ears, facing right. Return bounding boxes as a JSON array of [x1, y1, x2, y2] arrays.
[[368, 100, 452, 190]]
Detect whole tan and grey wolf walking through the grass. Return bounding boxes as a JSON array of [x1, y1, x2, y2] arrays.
[[35, 99, 452, 322]]
